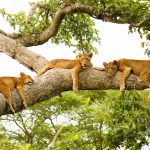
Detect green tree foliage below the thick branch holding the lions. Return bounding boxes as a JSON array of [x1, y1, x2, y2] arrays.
[[0, 91, 150, 150]]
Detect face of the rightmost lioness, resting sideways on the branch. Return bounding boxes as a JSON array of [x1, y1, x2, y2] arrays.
[[103, 60, 117, 76]]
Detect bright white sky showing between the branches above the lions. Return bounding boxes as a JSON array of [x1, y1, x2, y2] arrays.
[[0, 0, 148, 76]]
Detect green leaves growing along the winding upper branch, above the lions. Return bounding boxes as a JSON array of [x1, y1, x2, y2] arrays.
[[0, 0, 150, 53]]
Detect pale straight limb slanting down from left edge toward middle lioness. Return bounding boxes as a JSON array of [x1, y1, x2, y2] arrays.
[[0, 34, 48, 72]]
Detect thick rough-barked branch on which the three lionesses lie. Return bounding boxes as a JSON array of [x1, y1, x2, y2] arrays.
[[0, 69, 148, 115]]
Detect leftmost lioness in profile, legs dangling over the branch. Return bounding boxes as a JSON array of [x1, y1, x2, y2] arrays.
[[0, 72, 33, 113]]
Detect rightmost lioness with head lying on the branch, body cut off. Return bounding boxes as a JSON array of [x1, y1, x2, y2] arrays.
[[103, 59, 150, 90]]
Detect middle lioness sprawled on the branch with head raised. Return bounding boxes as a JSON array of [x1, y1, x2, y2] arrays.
[[36, 53, 93, 92]]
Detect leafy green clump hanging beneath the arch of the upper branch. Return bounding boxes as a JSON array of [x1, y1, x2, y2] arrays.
[[52, 13, 100, 53]]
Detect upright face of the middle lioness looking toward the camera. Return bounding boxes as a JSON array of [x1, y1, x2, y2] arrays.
[[78, 53, 93, 68]]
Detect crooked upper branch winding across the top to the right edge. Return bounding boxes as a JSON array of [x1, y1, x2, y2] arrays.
[[0, 3, 150, 47]]
